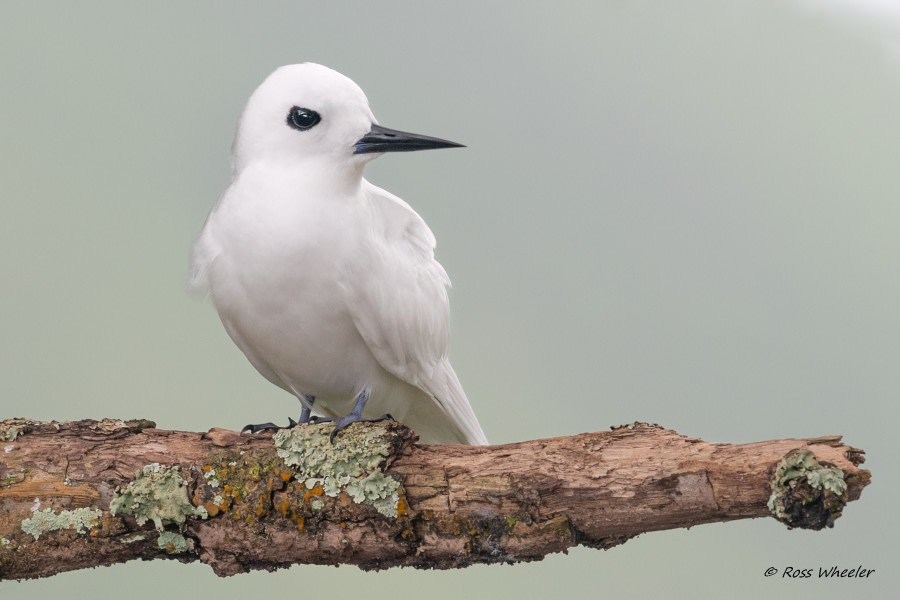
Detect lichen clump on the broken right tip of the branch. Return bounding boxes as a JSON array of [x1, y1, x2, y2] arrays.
[[768, 450, 847, 529]]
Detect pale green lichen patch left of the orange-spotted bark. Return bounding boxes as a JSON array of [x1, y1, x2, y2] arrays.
[[109, 463, 208, 531]]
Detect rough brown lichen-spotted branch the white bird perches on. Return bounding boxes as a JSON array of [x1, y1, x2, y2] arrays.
[[0, 419, 870, 579]]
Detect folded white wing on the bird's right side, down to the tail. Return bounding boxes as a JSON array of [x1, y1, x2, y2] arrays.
[[344, 180, 488, 444]]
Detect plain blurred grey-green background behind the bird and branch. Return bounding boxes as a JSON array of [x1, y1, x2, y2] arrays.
[[0, 0, 900, 600]]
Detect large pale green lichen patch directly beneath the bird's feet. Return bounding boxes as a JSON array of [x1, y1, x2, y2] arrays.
[[274, 424, 400, 517]]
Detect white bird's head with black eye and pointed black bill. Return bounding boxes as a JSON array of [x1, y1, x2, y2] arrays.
[[234, 63, 461, 175]]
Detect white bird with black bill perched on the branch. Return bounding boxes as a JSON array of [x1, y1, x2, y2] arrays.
[[190, 63, 488, 445]]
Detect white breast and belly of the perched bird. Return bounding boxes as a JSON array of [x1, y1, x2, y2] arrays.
[[199, 168, 382, 414]]
